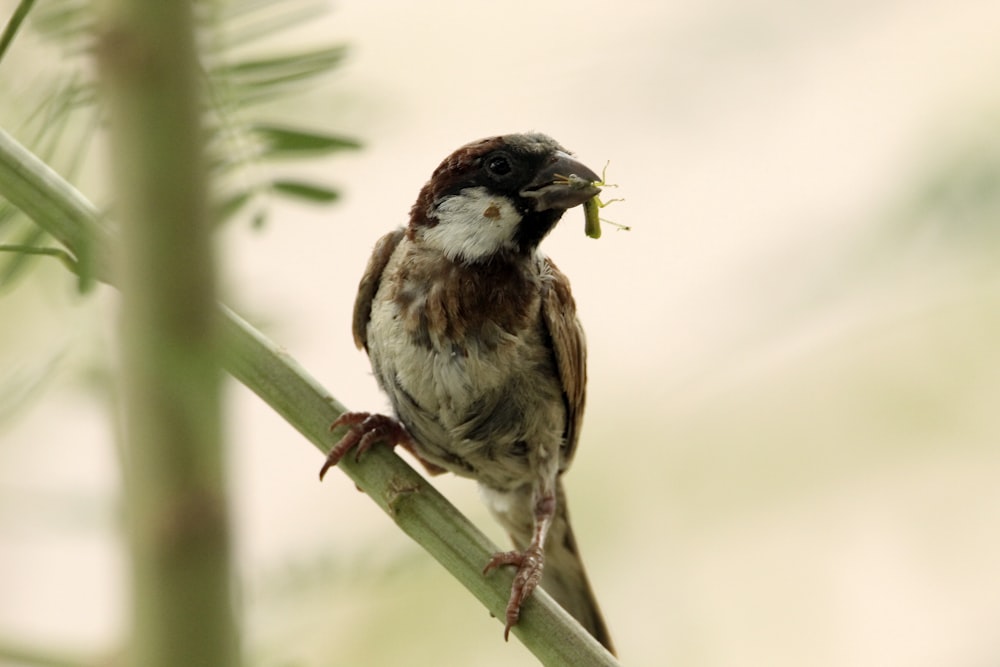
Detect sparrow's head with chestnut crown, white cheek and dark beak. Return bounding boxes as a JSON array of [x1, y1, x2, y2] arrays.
[[408, 134, 600, 264]]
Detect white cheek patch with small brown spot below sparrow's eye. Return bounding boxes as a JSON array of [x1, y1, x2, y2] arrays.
[[423, 187, 521, 262]]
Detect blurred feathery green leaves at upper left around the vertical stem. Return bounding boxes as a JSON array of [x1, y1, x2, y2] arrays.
[[0, 0, 360, 290]]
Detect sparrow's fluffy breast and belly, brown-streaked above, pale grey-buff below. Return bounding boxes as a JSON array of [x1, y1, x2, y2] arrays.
[[368, 243, 565, 484]]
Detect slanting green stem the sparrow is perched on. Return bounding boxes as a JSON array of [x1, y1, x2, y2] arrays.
[[0, 124, 618, 667]]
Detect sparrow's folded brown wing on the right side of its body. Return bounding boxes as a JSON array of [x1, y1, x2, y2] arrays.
[[542, 258, 587, 468]]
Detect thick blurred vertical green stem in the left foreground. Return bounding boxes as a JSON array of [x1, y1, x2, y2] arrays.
[[96, 0, 240, 667]]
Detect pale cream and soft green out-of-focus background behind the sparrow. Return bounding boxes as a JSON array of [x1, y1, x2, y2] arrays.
[[0, 0, 1000, 667]]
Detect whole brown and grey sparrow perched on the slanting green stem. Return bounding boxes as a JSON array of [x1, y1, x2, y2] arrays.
[[320, 134, 612, 650]]
